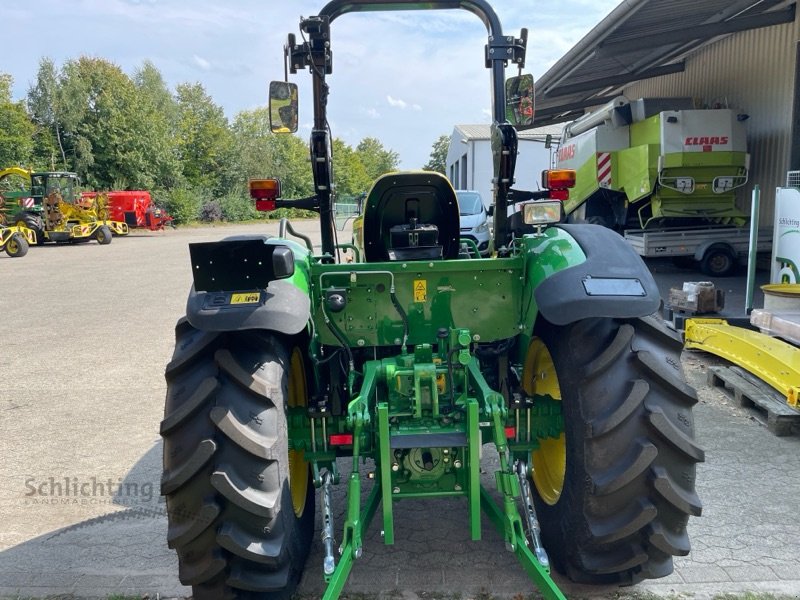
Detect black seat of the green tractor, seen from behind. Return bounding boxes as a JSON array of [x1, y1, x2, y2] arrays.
[[364, 171, 460, 262]]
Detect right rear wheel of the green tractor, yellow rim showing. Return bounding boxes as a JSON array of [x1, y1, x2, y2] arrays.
[[523, 318, 704, 584]]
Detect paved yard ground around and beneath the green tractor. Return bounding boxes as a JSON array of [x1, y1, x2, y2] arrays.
[[0, 223, 800, 600]]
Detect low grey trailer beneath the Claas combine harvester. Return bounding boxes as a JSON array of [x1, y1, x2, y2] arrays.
[[624, 227, 772, 277]]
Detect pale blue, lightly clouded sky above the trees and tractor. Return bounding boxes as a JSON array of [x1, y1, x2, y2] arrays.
[[0, 0, 619, 169]]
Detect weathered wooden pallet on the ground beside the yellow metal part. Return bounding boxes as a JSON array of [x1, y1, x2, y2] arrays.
[[708, 367, 800, 436]]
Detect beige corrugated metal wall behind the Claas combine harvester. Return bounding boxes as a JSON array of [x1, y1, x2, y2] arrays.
[[625, 19, 800, 227]]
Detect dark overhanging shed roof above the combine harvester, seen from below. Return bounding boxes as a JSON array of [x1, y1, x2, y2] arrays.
[[534, 0, 795, 126]]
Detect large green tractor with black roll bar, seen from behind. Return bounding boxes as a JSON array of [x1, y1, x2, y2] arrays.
[[161, 0, 703, 599]]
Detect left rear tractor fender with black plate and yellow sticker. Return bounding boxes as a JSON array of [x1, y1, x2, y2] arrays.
[[186, 236, 311, 335]]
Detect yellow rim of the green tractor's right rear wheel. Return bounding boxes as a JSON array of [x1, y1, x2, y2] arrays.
[[522, 338, 567, 505]]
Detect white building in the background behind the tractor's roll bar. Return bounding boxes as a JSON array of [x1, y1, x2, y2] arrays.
[[446, 124, 563, 207]]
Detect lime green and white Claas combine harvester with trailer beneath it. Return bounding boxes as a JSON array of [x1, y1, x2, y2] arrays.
[[557, 96, 770, 276]]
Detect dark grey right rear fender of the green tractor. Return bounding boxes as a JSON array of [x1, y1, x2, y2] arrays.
[[534, 224, 661, 325]]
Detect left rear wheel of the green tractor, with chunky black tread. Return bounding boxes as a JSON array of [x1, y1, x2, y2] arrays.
[[161, 319, 314, 600]]
